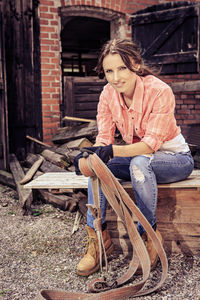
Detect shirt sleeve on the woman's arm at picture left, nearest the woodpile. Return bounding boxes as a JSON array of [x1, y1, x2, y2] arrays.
[[96, 90, 116, 145]]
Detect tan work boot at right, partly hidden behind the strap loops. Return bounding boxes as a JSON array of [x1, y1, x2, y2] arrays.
[[135, 229, 163, 274]]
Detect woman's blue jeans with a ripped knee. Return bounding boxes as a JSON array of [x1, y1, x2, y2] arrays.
[[87, 151, 194, 235]]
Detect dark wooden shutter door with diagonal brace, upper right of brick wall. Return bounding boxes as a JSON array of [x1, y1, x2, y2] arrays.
[[131, 1, 200, 74]]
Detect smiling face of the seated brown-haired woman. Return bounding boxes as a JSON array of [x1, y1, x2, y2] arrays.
[[103, 53, 136, 99]]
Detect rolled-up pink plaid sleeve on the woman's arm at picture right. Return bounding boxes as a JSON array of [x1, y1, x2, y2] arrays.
[[141, 87, 180, 151]]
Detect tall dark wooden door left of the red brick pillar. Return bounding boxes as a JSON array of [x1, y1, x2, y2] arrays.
[[3, 0, 42, 159]]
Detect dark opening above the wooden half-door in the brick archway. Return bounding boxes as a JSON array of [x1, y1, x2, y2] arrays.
[[61, 17, 110, 76]]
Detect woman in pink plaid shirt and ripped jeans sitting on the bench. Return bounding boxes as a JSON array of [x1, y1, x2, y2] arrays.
[[74, 39, 194, 276]]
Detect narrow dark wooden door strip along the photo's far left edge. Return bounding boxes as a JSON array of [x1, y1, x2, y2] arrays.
[[0, 2, 8, 170]]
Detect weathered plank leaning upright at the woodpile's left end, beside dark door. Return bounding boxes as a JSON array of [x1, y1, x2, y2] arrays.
[[10, 154, 33, 210]]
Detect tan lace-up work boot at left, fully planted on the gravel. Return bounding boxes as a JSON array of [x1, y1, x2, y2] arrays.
[[77, 226, 114, 276]]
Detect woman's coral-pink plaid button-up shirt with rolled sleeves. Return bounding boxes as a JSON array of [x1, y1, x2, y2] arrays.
[[96, 75, 181, 151]]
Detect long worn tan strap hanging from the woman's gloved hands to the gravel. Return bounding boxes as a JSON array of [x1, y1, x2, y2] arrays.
[[38, 153, 168, 300]]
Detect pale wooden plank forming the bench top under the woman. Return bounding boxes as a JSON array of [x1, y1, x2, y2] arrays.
[[23, 170, 200, 189]]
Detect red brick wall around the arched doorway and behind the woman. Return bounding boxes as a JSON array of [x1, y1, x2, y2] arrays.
[[39, 0, 200, 143]]
